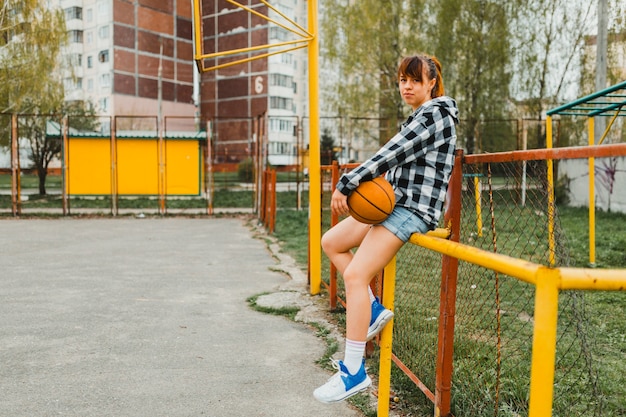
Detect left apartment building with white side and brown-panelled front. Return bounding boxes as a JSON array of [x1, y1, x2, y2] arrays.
[[56, 0, 197, 129]]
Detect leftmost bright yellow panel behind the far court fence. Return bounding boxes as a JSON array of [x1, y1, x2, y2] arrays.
[[66, 138, 111, 194]]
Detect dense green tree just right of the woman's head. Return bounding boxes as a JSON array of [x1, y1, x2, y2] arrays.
[[428, 0, 510, 154]]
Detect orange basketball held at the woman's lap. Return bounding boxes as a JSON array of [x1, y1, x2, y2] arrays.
[[348, 177, 396, 224]]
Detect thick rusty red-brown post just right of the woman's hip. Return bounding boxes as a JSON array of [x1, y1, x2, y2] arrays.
[[435, 150, 463, 417]]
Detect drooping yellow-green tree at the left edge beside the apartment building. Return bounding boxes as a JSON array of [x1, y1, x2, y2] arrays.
[[0, 0, 96, 194]]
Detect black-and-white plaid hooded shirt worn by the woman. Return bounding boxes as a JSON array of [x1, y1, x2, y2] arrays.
[[337, 96, 459, 229]]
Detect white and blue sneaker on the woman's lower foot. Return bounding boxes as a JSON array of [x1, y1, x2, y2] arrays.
[[313, 359, 372, 404]]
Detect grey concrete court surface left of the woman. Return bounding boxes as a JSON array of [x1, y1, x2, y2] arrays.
[[0, 217, 361, 417]]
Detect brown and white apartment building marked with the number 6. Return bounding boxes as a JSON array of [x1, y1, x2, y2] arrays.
[[196, 0, 308, 167]]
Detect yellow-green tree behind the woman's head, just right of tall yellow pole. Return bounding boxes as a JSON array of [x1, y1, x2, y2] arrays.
[[322, 0, 423, 144]]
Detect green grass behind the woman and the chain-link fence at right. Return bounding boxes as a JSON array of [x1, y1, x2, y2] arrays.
[[276, 206, 626, 417]]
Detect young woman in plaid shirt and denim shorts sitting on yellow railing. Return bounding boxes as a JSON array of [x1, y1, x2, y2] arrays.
[[313, 55, 458, 403]]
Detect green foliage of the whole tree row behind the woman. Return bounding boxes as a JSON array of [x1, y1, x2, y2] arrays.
[[321, 0, 626, 153]]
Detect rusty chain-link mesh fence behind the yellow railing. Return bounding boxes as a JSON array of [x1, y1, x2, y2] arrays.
[[322, 123, 625, 417]]
